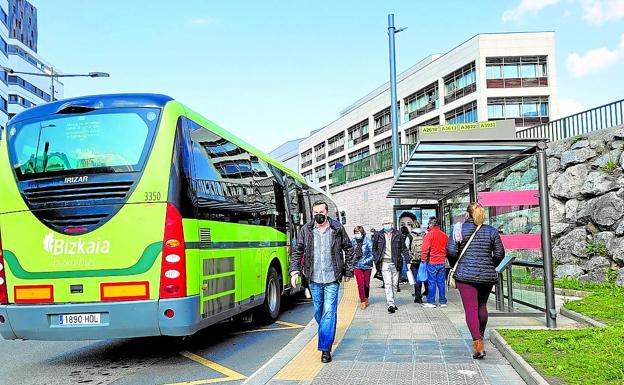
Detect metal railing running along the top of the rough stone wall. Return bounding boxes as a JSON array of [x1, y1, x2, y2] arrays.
[[516, 99, 624, 141]]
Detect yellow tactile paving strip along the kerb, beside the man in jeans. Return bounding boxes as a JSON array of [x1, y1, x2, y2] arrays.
[[275, 280, 360, 381]]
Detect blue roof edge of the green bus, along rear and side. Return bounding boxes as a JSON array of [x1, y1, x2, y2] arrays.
[[9, 93, 310, 185]]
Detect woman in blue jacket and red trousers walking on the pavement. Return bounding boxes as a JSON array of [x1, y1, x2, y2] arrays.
[[351, 226, 373, 310]]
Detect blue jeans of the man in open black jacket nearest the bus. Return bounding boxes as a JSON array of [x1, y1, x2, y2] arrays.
[[310, 281, 340, 352]]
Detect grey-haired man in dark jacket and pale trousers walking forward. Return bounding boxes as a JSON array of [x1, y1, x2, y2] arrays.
[[373, 217, 409, 313]]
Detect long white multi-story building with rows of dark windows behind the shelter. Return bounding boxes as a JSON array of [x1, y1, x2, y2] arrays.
[[299, 32, 557, 230]]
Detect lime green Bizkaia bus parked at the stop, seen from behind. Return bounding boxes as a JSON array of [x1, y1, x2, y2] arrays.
[[0, 94, 338, 340]]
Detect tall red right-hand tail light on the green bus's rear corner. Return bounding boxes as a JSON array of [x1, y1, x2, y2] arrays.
[[160, 203, 186, 298]]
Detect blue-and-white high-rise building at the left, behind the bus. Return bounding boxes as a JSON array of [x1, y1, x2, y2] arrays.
[[0, 0, 63, 127]]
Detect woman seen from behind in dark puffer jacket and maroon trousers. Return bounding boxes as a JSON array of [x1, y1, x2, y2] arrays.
[[447, 203, 505, 359]]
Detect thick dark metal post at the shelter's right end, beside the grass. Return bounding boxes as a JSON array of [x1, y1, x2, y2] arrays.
[[537, 142, 557, 328]]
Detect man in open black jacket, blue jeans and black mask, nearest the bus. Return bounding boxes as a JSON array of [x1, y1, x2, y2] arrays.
[[289, 201, 353, 363]]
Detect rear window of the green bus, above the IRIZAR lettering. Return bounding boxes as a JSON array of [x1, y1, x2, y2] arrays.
[[7, 108, 160, 179]]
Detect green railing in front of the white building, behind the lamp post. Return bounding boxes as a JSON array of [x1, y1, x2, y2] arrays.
[[331, 144, 416, 187]]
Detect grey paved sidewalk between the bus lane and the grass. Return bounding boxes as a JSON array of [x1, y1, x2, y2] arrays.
[[269, 280, 544, 385]]
